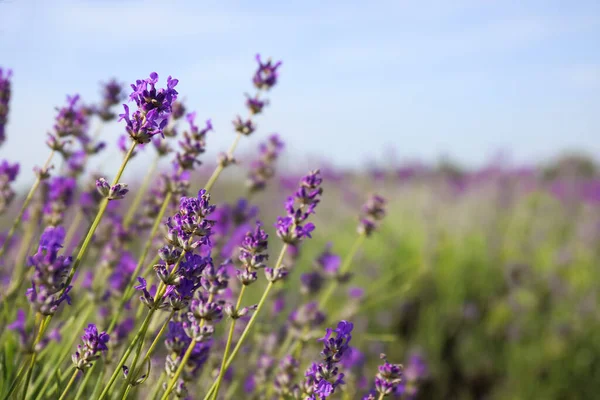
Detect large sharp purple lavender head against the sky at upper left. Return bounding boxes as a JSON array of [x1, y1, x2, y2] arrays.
[[119, 72, 179, 144]]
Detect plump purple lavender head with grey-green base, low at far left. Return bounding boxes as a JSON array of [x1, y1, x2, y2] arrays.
[[27, 226, 72, 315]]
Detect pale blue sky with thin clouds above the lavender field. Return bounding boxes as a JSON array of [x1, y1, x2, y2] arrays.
[[0, 0, 600, 183]]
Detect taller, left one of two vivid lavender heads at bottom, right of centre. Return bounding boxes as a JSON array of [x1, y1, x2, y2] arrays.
[[301, 321, 354, 400]]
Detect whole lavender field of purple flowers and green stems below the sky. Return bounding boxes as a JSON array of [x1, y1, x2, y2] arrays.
[[0, 56, 600, 399]]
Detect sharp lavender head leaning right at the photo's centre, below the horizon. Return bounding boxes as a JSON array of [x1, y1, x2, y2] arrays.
[[275, 170, 323, 245]]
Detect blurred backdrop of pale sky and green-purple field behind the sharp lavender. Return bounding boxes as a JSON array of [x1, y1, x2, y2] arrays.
[[0, 0, 600, 399]]
